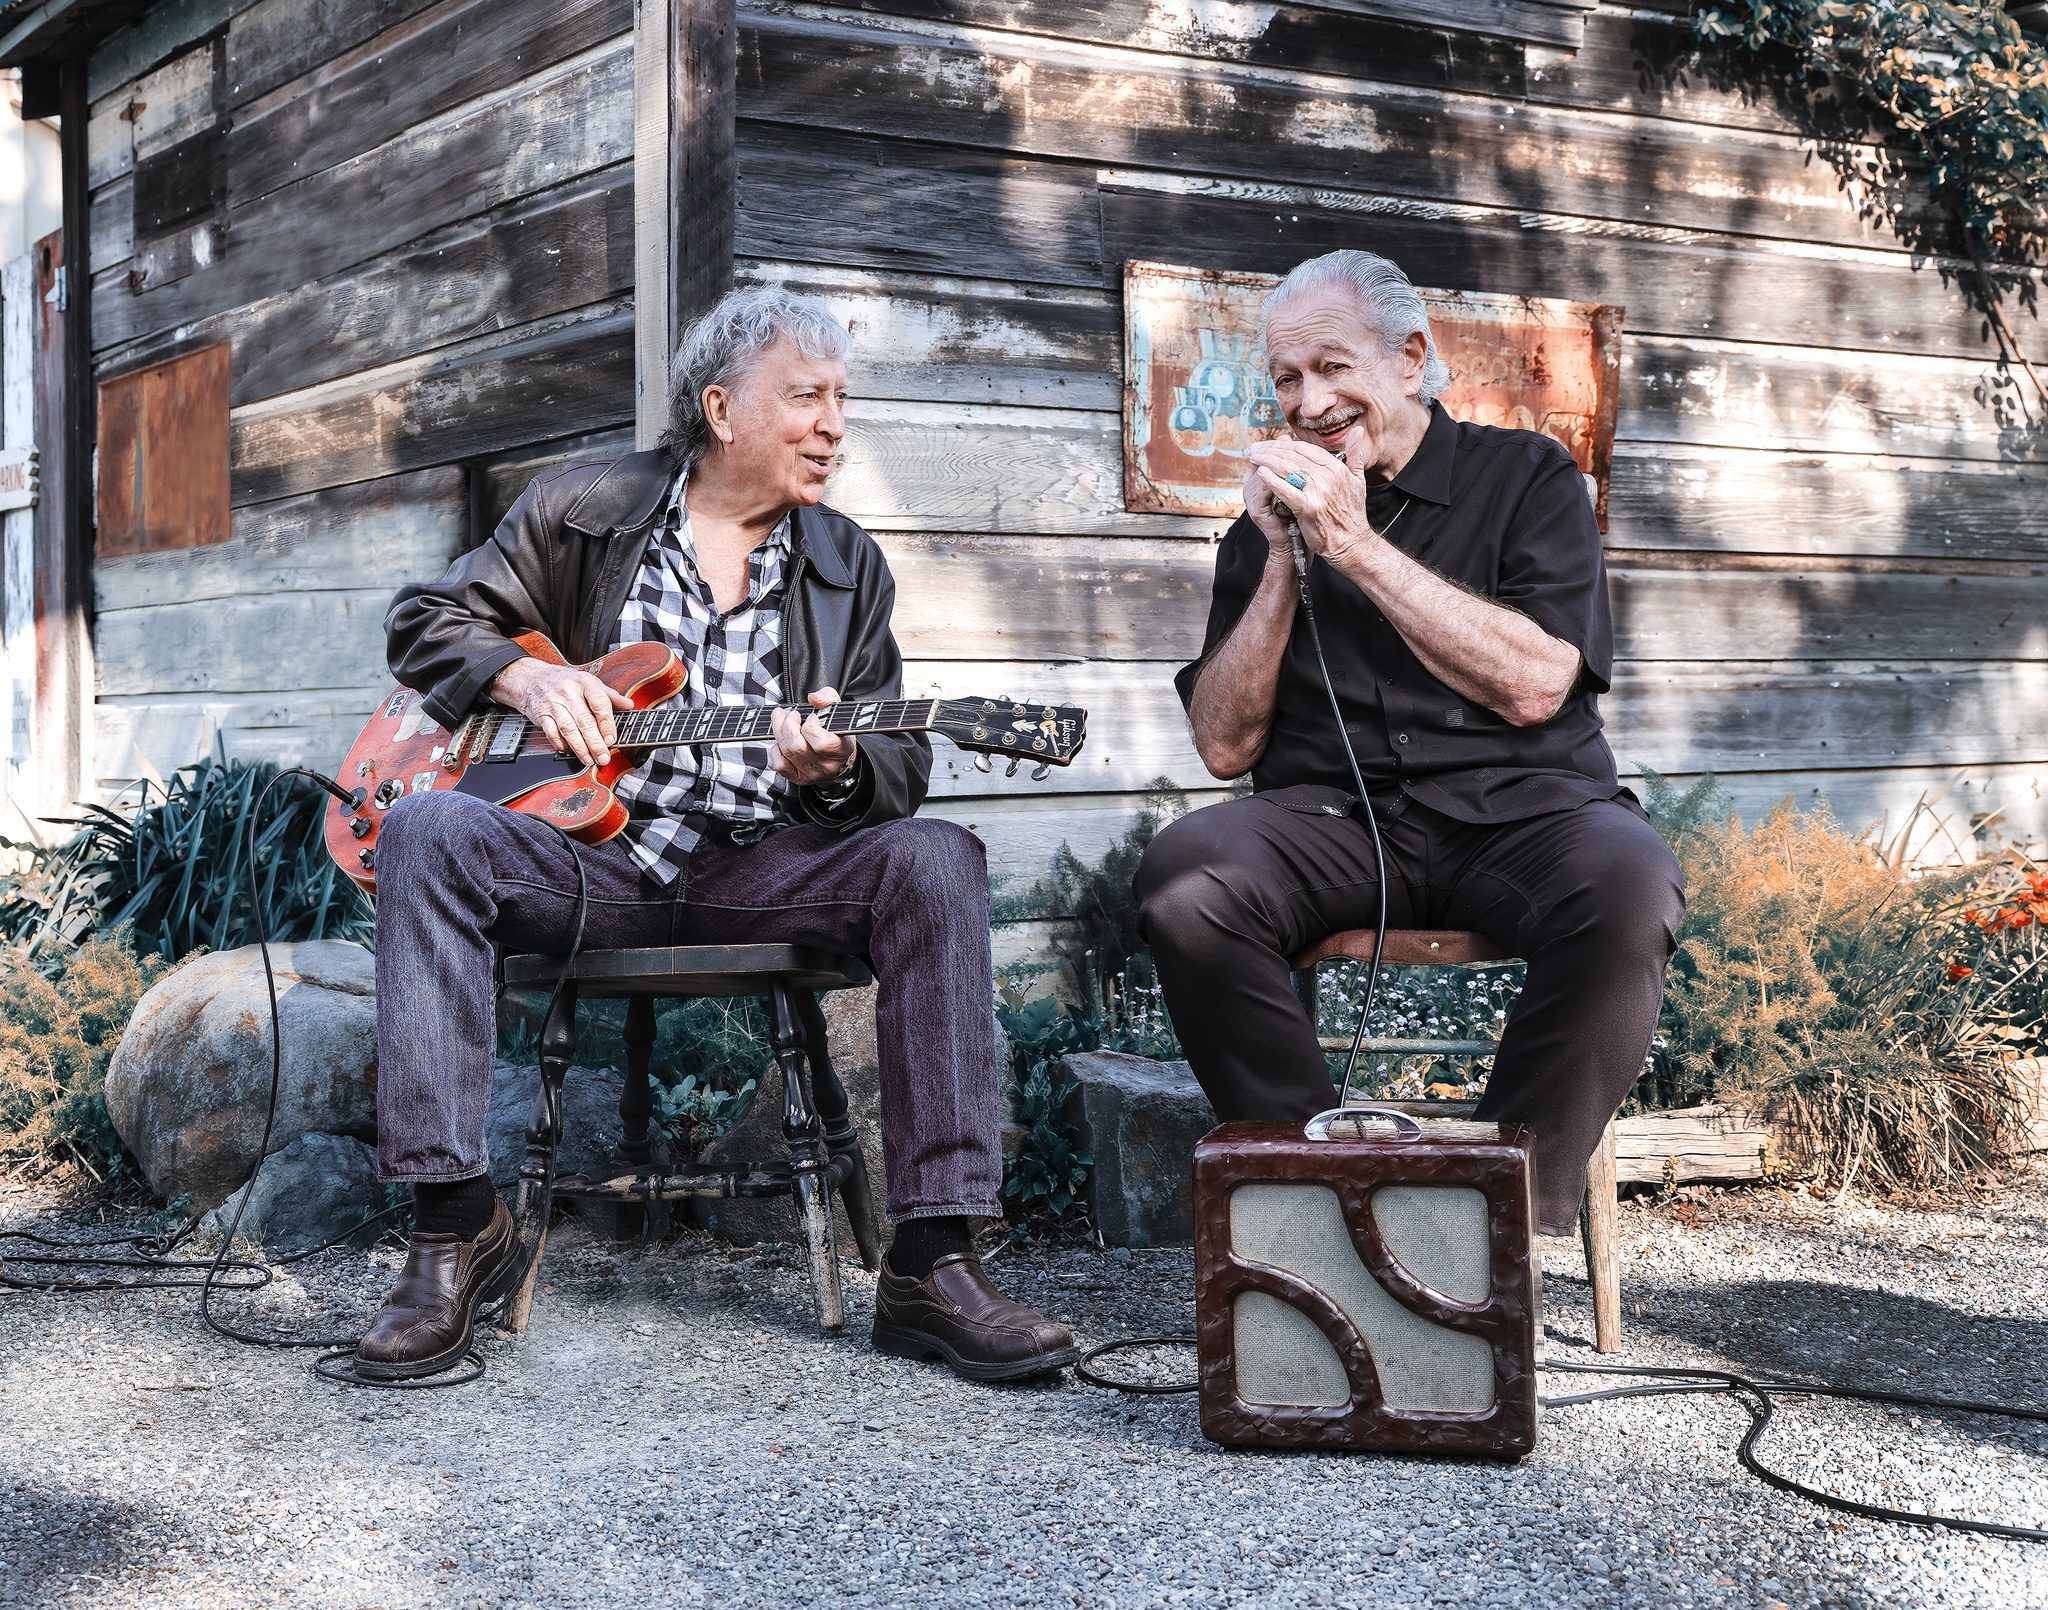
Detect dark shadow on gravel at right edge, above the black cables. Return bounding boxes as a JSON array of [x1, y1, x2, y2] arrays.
[[1624, 1280, 2048, 1454]]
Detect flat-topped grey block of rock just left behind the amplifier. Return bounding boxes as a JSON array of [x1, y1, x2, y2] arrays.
[[1061, 1051, 1217, 1247]]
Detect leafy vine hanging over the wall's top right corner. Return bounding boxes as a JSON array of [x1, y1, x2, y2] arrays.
[[1694, 0, 2048, 401]]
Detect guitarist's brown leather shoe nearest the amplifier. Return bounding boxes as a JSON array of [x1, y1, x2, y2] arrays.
[[874, 1252, 1081, 1381]]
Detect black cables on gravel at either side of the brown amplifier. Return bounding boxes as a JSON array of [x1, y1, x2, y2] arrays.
[[1073, 1336, 2048, 1542]]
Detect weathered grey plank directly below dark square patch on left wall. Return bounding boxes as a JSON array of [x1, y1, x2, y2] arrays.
[[94, 45, 633, 348]]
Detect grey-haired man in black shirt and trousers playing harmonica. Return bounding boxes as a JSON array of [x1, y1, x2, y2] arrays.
[[1137, 252, 1683, 1235]]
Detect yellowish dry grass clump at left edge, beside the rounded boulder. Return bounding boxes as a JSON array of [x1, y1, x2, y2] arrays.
[[0, 930, 166, 1180]]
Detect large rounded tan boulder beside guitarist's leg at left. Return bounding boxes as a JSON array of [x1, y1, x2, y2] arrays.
[[106, 940, 377, 1206]]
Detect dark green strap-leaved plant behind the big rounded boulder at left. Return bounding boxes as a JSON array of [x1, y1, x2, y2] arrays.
[[0, 758, 375, 961]]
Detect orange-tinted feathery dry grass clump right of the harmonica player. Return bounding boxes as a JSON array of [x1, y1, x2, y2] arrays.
[[1645, 793, 2042, 1188]]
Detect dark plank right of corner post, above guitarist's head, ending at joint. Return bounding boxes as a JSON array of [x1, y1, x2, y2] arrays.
[[735, 125, 1112, 287]]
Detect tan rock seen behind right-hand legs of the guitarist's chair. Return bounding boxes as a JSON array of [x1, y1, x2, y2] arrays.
[[694, 970, 889, 1252]]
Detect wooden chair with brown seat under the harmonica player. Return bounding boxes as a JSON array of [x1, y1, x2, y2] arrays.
[[1294, 928, 1622, 1352]]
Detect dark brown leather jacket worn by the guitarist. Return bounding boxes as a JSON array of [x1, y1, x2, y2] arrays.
[[385, 453, 932, 832]]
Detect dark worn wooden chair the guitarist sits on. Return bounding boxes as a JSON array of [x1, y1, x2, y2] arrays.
[[498, 944, 883, 1333]]
